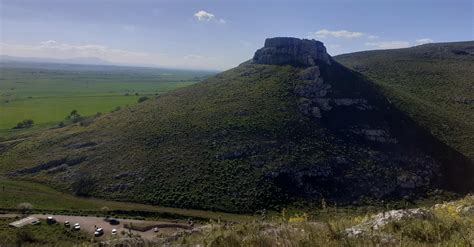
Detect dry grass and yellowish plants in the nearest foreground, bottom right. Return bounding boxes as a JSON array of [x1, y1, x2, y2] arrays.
[[175, 196, 474, 247]]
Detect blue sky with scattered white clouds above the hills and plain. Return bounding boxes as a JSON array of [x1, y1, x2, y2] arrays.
[[0, 0, 474, 70]]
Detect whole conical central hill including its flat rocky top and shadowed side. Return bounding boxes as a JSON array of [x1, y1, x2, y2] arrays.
[[0, 38, 473, 212]]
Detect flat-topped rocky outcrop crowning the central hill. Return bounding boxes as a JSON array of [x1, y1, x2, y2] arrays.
[[253, 37, 331, 66]]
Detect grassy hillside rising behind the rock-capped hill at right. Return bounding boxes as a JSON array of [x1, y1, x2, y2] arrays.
[[335, 42, 474, 160]]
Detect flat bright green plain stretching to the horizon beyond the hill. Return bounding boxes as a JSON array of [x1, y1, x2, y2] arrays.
[[0, 63, 213, 132]]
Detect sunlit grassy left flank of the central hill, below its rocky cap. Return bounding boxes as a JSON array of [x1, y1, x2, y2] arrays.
[[1, 66, 304, 210]]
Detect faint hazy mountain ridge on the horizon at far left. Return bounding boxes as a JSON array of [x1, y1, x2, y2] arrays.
[[0, 55, 113, 65]]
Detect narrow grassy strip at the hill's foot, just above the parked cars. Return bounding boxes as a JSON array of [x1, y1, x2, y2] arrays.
[[0, 178, 253, 222]]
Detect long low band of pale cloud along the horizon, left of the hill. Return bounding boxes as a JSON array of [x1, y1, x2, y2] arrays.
[[0, 40, 230, 69]]
